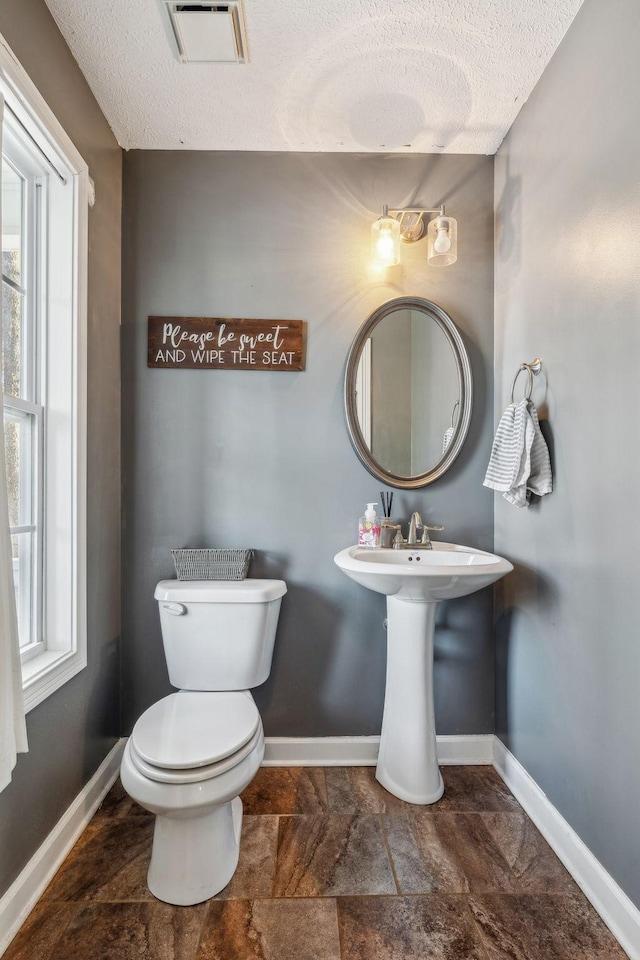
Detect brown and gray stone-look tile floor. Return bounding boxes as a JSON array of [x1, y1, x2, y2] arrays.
[[4, 767, 626, 960]]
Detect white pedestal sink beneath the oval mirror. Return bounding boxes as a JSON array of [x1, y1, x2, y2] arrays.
[[334, 543, 513, 804]]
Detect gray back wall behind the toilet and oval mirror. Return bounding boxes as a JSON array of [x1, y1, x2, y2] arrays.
[[123, 151, 494, 736]]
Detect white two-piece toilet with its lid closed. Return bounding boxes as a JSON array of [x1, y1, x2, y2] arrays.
[[120, 579, 287, 906]]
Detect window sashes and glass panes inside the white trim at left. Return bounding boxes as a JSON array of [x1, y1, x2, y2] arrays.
[[2, 124, 46, 662]]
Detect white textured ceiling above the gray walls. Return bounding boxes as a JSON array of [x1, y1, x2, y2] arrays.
[[46, 0, 582, 154]]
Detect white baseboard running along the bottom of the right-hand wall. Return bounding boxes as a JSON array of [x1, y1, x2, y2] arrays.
[[494, 737, 640, 960]]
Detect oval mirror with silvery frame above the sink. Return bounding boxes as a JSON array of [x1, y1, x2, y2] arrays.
[[344, 297, 473, 489]]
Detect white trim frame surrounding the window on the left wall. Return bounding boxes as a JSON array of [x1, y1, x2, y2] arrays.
[[0, 34, 93, 711]]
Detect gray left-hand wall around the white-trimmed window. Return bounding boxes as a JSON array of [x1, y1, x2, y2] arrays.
[[0, 0, 122, 895]]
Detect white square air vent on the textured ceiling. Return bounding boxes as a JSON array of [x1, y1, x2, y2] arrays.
[[165, 0, 249, 63]]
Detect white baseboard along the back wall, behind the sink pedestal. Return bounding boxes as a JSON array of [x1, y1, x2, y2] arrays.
[[262, 734, 494, 767]]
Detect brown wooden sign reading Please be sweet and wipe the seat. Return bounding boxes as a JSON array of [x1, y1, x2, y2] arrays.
[[147, 317, 306, 370]]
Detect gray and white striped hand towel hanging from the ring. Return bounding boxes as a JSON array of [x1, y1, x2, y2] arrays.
[[484, 399, 552, 507]]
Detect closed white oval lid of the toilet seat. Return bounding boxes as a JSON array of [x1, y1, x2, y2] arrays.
[[131, 690, 260, 770]]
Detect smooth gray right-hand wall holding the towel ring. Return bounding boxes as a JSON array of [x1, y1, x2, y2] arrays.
[[495, 0, 640, 906]]
